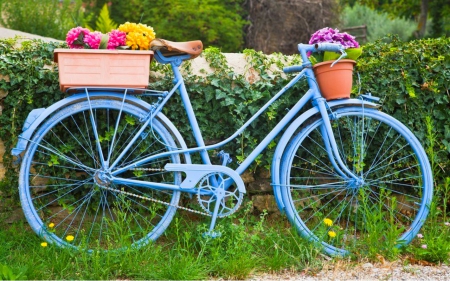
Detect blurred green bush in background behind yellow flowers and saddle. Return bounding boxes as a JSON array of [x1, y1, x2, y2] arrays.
[[85, 0, 247, 52]]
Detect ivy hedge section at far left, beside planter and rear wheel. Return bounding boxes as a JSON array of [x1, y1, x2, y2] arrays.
[[0, 39, 64, 194]]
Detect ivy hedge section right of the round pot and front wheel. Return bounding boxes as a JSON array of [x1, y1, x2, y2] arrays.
[[358, 37, 450, 182]]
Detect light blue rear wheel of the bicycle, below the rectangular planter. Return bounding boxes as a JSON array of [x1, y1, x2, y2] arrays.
[[19, 99, 184, 250]]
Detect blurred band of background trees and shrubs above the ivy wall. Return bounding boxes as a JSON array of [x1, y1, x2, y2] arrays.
[[0, 0, 450, 54]]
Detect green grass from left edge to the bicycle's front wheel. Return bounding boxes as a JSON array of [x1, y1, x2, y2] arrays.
[[0, 202, 323, 280]]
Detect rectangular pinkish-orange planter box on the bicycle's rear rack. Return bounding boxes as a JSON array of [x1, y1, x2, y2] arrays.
[[54, 49, 153, 91]]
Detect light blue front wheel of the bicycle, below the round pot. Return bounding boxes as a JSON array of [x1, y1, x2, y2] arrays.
[[280, 107, 433, 255]]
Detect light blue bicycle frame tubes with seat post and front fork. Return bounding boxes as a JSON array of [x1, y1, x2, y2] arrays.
[[108, 45, 357, 194]]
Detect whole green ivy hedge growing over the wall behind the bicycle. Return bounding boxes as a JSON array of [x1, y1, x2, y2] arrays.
[[0, 37, 450, 201]]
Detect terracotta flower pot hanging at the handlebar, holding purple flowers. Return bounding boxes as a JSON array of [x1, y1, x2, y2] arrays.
[[313, 59, 356, 100]]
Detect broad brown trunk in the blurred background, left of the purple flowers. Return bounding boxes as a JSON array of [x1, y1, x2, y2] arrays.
[[245, 0, 339, 55]]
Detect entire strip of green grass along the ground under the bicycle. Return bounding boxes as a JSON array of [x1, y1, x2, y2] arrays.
[[0, 190, 450, 280]]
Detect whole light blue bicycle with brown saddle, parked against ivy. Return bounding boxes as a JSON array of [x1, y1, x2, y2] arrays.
[[13, 40, 433, 255]]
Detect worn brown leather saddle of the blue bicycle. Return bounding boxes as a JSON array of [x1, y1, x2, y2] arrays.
[[150, 39, 203, 59]]
